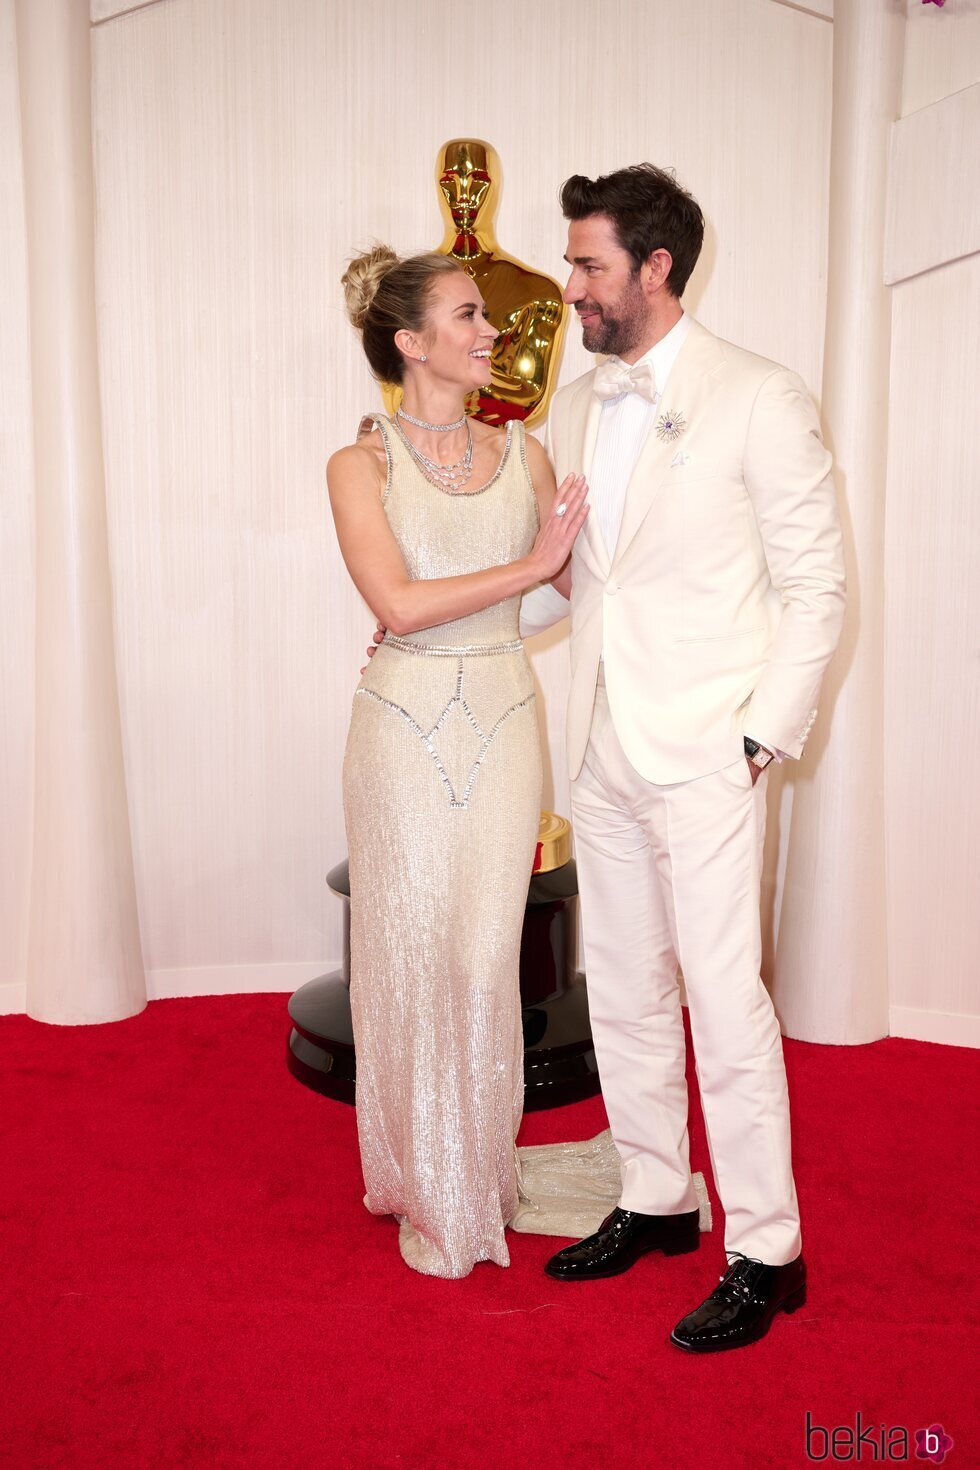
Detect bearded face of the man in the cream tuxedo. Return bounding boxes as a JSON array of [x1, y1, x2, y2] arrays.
[[564, 215, 649, 356]]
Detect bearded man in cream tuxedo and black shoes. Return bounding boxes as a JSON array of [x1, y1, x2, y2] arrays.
[[522, 165, 843, 1352]]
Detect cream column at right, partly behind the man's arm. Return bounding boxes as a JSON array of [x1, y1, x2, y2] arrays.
[[773, 0, 905, 1042]]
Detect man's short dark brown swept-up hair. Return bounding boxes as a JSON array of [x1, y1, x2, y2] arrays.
[[558, 163, 704, 297]]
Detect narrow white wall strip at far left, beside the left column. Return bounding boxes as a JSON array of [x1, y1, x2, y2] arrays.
[[0, 0, 34, 1011]]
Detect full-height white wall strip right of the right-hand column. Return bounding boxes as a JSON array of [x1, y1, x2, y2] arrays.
[[884, 0, 980, 1045]]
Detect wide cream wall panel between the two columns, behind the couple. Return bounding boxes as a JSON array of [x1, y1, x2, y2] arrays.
[[94, 0, 832, 985]]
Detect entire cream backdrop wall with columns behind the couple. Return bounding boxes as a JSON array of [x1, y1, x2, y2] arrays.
[[0, 0, 980, 1041]]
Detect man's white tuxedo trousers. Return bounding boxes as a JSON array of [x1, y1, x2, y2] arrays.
[[572, 681, 801, 1266]]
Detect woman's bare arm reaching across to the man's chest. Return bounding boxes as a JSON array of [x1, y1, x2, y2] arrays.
[[326, 444, 589, 634]]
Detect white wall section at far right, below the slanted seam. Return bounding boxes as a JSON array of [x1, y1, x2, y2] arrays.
[[884, 256, 980, 1044]]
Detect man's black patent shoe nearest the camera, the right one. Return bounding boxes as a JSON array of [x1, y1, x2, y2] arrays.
[[670, 1252, 807, 1352]]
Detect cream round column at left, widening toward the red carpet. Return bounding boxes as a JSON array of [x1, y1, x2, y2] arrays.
[[16, 0, 145, 1023]]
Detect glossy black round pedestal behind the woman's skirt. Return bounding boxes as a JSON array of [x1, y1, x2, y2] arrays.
[[287, 863, 599, 1111]]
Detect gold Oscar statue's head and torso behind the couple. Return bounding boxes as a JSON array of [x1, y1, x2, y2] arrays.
[[382, 138, 566, 425]]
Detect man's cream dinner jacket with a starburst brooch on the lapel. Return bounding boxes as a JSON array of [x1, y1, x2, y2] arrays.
[[522, 322, 845, 785]]
